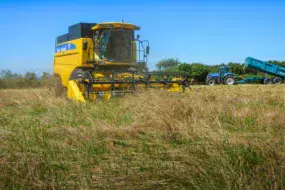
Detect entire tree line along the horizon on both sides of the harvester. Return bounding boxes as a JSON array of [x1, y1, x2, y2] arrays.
[[0, 58, 285, 89]]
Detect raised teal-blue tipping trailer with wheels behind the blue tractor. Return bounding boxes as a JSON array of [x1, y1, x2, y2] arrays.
[[245, 57, 285, 84]]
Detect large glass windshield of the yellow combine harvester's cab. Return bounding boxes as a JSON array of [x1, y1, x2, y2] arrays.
[[99, 29, 134, 62]]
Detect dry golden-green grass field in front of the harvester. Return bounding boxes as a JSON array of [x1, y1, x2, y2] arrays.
[[0, 85, 285, 189]]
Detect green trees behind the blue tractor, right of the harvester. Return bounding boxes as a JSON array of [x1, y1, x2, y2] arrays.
[[156, 58, 285, 83]]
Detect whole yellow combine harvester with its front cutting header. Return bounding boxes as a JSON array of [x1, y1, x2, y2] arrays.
[[54, 22, 189, 102]]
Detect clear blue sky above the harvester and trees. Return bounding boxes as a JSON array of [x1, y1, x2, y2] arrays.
[[0, 0, 285, 73]]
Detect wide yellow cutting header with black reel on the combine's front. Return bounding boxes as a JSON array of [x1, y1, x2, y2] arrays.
[[68, 69, 189, 102]]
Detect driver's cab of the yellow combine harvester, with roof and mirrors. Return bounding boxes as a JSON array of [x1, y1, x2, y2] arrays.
[[92, 22, 149, 68]]
